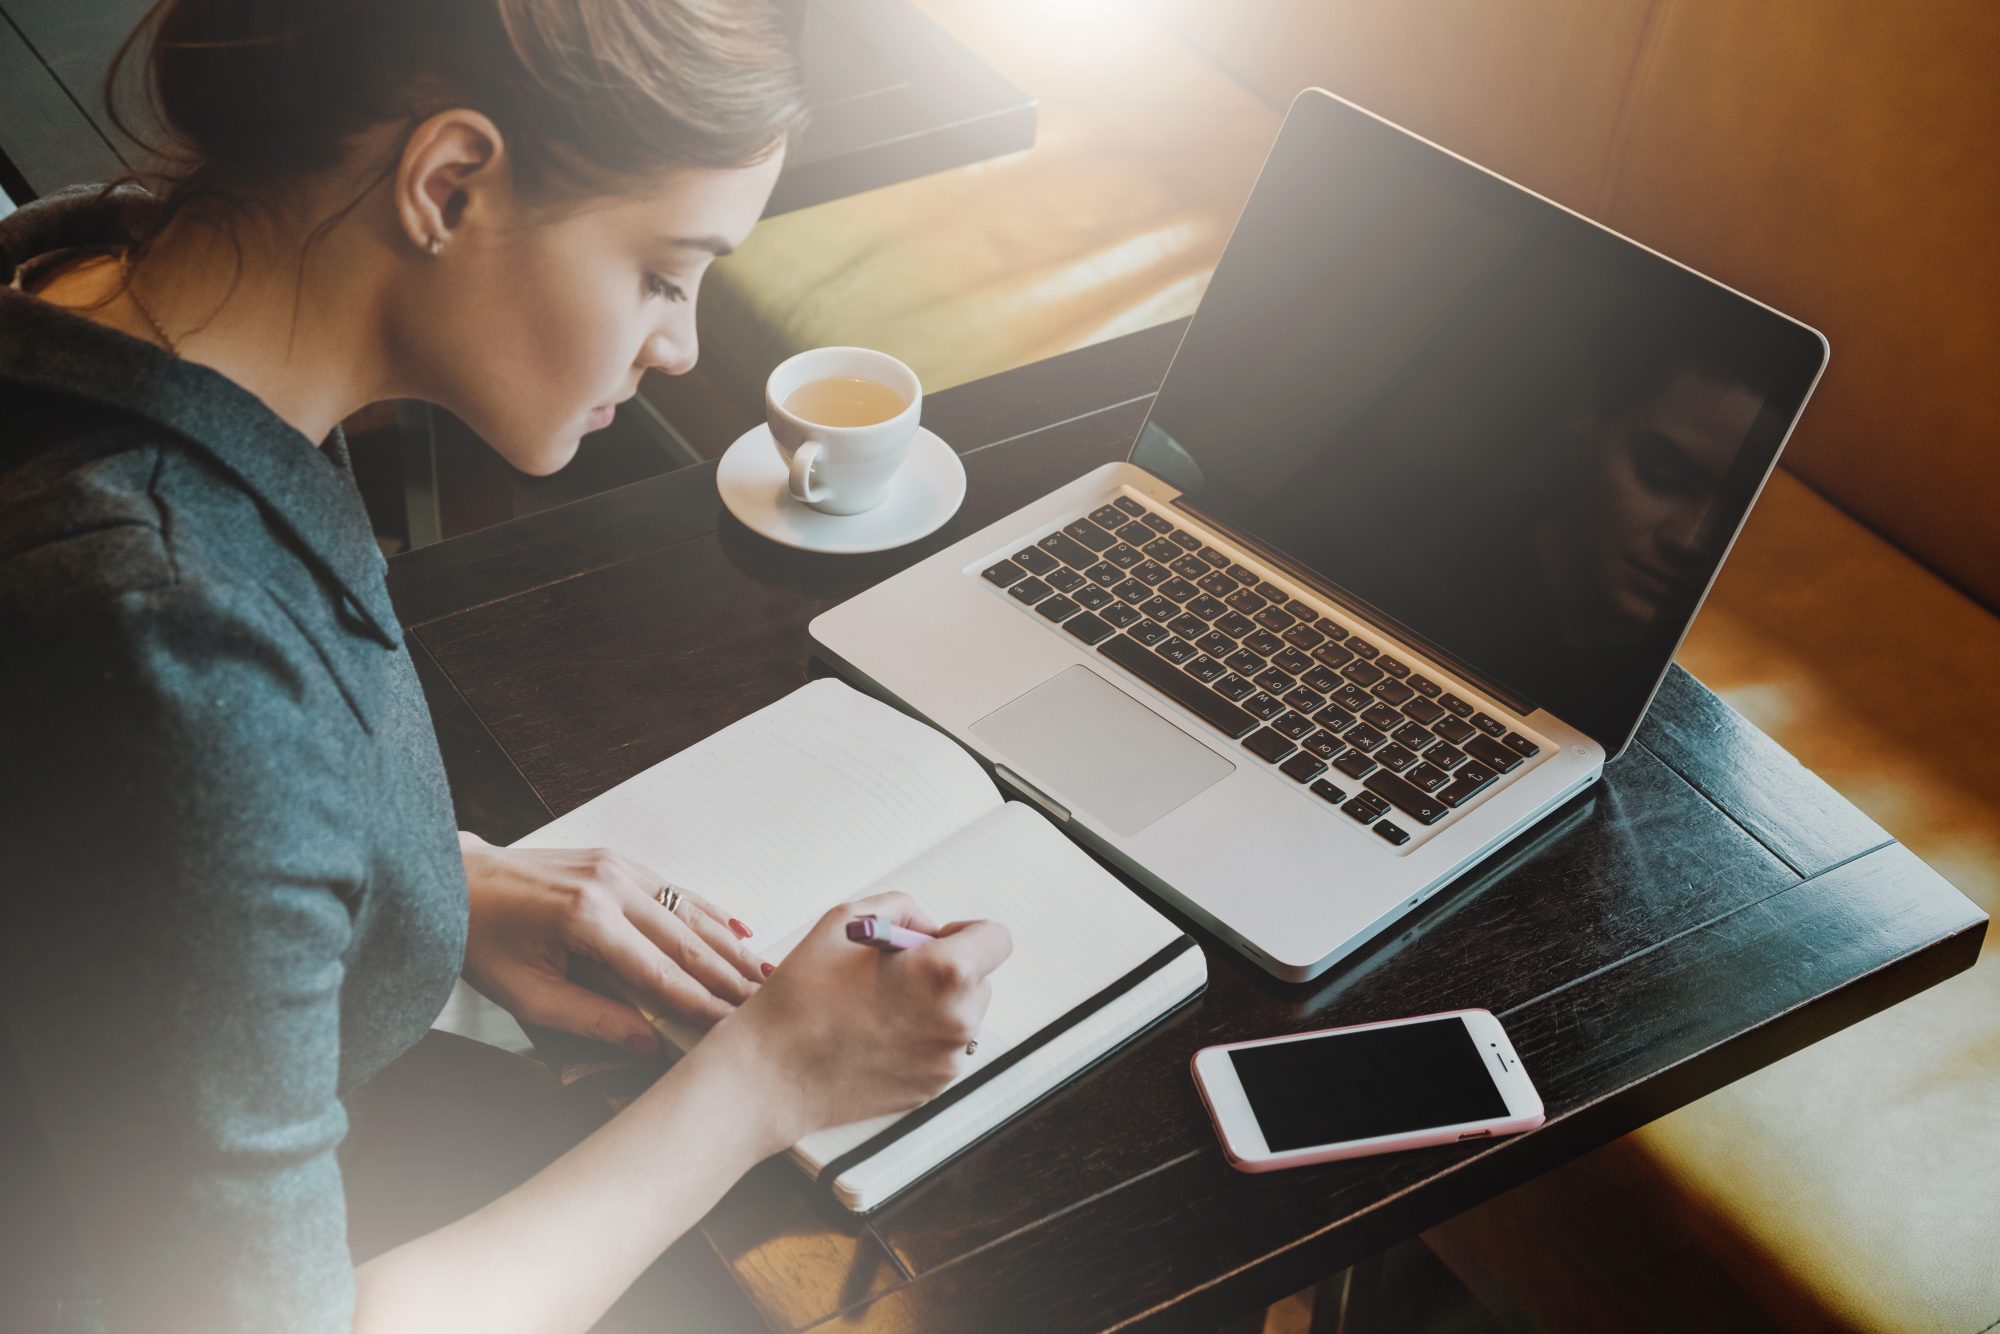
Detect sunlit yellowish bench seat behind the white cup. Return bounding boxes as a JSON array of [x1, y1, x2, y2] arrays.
[[702, 0, 1280, 416]]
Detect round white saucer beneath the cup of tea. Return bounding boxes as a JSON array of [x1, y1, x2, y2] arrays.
[[716, 422, 966, 554]]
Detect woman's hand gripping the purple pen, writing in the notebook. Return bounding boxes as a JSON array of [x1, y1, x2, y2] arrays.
[[702, 894, 1014, 1148]]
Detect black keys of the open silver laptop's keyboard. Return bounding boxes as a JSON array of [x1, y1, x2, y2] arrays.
[[980, 496, 1542, 848]]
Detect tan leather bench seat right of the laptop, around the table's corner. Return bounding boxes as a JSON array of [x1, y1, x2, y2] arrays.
[[1432, 470, 2000, 1334]]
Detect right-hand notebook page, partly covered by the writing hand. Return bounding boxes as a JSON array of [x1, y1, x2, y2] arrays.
[[794, 802, 1180, 1172]]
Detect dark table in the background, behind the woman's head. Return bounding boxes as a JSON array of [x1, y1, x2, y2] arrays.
[[0, 0, 1034, 216]]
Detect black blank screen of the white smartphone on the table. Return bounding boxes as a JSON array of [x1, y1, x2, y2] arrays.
[[1230, 1016, 1506, 1152]]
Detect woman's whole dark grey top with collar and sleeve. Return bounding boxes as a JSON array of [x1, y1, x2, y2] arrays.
[[0, 192, 466, 1334]]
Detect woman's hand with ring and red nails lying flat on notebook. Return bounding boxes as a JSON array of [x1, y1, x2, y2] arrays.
[[458, 832, 764, 1056]]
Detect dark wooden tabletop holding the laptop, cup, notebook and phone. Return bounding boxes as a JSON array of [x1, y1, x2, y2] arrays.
[[390, 324, 1986, 1330]]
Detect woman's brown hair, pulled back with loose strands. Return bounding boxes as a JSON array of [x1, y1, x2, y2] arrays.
[[106, 0, 804, 258]]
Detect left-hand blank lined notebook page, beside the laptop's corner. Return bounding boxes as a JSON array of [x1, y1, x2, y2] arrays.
[[514, 678, 1000, 940]]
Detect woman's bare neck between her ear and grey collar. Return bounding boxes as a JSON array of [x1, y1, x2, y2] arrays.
[[121, 190, 404, 442]]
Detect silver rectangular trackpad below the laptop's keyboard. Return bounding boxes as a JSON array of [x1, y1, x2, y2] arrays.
[[972, 664, 1236, 834]]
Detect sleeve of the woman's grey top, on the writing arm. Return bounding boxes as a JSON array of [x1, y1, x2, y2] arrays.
[[0, 582, 362, 1334]]
